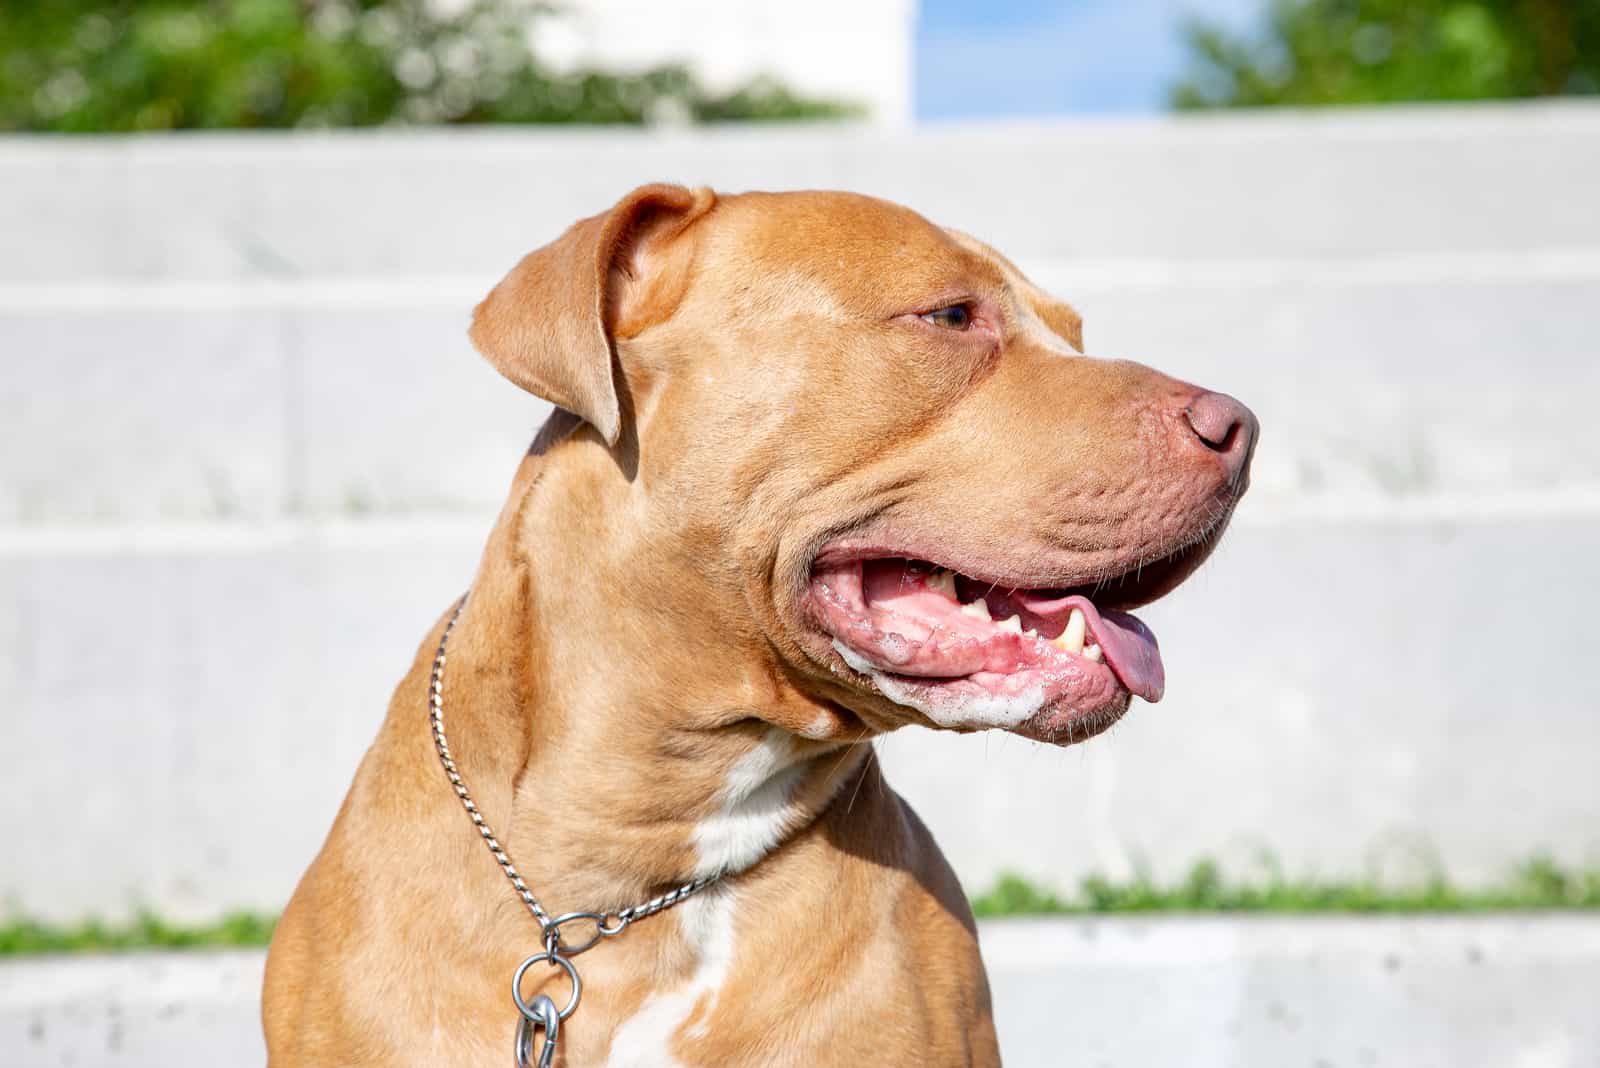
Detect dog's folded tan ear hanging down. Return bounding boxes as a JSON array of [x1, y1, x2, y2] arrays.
[[469, 185, 715, 446]]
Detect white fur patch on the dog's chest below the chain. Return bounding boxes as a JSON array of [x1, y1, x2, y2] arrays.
[[606, 886, 738, 1068]]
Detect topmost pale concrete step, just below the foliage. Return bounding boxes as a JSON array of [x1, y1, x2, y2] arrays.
[[0, 101, 1600, 281]]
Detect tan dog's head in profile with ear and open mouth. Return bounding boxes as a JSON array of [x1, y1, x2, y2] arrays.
[[472, 185, 1256, 742]]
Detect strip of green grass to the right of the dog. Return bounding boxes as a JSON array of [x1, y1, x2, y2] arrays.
[[973, 857, 1600, 916]]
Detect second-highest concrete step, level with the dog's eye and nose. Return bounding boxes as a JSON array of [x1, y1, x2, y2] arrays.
[[0, 262, 1600, 524]]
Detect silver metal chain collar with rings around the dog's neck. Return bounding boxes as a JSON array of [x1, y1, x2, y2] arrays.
[[427, 590, 722, 1068]]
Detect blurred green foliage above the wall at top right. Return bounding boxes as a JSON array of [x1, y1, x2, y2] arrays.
[[1171, 0, 1600, 109]]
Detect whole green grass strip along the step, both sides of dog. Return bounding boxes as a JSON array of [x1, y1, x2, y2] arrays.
[[0, 857, 1600, 956]]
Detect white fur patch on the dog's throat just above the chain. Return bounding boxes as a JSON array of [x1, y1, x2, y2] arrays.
[[694, 727, 805, 879]]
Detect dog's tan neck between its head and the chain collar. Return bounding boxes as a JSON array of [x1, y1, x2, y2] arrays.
[[446, 434, 870, 913]]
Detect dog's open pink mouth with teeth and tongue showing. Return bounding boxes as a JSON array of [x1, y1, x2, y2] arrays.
[[811, 556, 1187, 740]]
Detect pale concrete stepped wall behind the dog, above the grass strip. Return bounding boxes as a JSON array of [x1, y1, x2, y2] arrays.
[[0, 106, 1600, 916]]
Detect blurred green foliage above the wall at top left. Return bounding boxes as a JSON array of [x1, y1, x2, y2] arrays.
[[0, 0, 856, 133]]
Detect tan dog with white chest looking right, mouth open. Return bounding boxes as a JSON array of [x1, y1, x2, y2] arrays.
[[264, 185, 1256, 1068]]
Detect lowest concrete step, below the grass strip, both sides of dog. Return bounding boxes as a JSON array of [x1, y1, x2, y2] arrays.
[[0, 915, 1600, 1068]]
